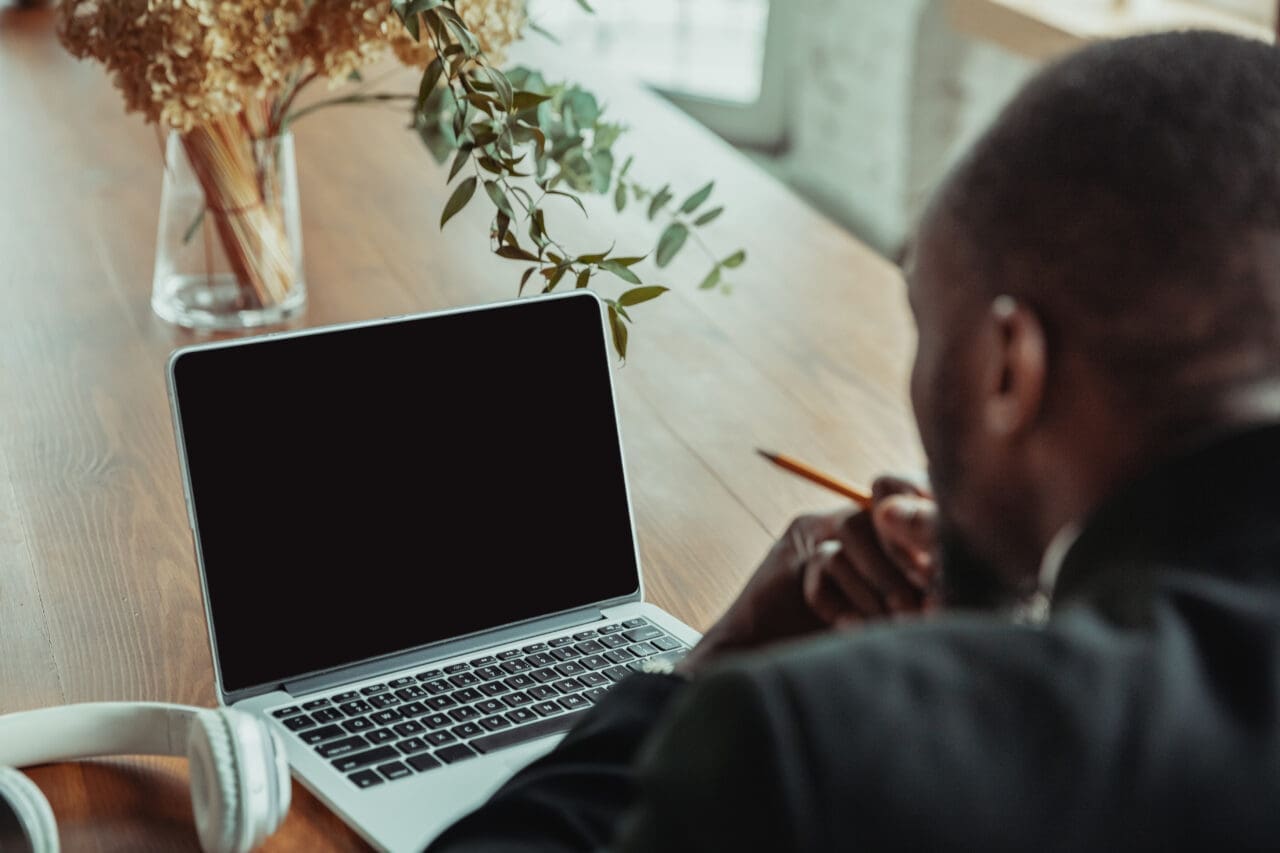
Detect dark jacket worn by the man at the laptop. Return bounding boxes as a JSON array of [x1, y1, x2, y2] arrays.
[[431, 427, 1280, 853]]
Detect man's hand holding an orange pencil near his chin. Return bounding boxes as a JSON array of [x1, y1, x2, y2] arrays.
[[678, 476, 937, 674]]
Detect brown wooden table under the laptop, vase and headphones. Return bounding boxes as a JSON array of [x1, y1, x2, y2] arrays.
[[0, 9, 920, 850]]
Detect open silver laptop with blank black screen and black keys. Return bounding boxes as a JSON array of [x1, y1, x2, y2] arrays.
[[169, 291, 698, 850]]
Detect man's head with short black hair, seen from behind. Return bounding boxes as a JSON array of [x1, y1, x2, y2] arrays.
[[908, 32, 1280, 603]]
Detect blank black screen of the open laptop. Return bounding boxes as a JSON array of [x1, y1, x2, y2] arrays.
[[173, 295, 639, 693]]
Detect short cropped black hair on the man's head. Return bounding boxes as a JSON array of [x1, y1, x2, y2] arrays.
[[931, 31, 1280, 397]]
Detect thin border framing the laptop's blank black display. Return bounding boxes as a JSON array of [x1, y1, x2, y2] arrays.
[[165, 291, 644, 706]]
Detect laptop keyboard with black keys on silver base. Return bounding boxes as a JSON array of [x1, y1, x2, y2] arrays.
[[270, 619, 689, 788]]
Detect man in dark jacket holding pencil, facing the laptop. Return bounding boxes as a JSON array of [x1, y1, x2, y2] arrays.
[[433, 33, 1280, 852]]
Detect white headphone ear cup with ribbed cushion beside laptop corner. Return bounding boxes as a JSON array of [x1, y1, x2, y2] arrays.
[[187, 708, 293, 853]]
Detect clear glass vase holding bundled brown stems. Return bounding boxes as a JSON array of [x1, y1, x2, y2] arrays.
[[151, 128, 307, 330]]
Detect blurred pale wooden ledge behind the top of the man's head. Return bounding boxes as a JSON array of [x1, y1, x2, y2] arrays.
[[947, 0, 1275, 59]]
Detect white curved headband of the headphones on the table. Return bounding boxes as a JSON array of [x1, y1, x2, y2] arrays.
[[0, 702, 196, 767]]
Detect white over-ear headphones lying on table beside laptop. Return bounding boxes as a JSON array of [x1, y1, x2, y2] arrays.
[[0, 702, 293, 853]]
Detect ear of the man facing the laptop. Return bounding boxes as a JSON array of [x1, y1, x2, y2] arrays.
[[983, 296, 1048, 438]]
